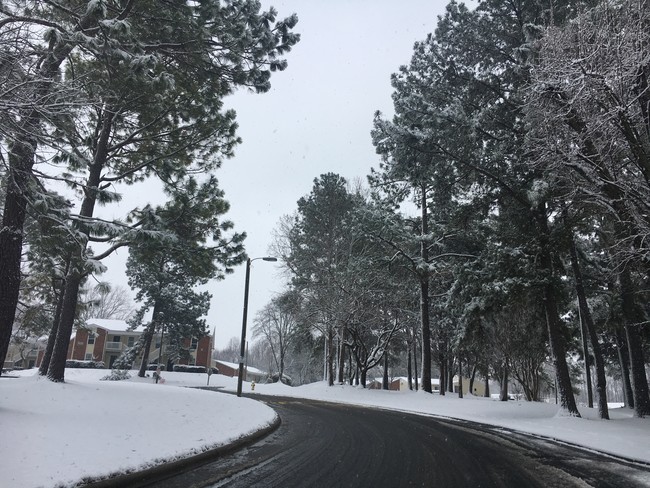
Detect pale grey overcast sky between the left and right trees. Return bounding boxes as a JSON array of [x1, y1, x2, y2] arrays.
[[103, 0, 447, 348]]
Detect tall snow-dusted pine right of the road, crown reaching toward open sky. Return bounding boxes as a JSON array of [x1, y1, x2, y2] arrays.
[[368, 0, 579, 415]]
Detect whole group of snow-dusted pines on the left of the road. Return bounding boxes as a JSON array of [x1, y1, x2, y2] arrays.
[[0, 0, 299, 381]]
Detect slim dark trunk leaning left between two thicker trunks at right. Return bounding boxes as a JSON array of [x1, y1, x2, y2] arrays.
[[570, 236, 609, 419]]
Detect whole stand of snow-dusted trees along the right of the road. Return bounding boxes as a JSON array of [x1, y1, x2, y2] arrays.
[[251, 0, 650, 419]]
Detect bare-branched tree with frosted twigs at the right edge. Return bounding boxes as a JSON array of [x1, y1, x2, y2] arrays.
[[527, 2, 650, 416]]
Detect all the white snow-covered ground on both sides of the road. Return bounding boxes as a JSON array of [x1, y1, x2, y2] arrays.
[[0, 369, 650, 488]]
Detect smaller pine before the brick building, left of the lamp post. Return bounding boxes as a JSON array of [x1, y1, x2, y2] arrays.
[[127, 177, 246, 376]]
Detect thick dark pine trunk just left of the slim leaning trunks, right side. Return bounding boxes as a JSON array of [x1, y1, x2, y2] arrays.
[[536, 208, 580, 417]]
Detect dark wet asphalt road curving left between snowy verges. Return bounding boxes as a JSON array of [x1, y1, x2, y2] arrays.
[[140, 396, 650, 488]]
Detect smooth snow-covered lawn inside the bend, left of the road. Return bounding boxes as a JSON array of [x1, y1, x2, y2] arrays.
[[0, 369, 276, 488]]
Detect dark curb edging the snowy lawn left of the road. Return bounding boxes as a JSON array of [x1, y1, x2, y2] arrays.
[[74, 414, 282, 488]]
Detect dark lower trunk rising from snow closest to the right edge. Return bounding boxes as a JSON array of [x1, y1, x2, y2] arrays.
[[619, 267, 650, 418]]
